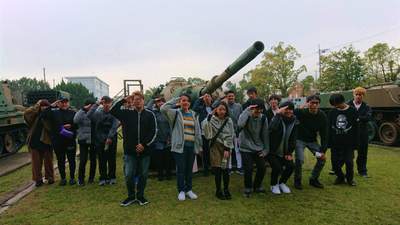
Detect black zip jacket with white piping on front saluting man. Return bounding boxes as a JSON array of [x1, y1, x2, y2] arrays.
[[110, 99, 157, 156]]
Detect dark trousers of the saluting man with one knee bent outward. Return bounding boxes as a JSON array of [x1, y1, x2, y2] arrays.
[[294, 139, 326, 180]]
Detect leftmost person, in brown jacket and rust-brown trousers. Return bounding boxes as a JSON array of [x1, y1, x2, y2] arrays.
[[24, 99, 54, 187]]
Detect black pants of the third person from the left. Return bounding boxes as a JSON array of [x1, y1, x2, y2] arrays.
[[79, 144, 97, 180]]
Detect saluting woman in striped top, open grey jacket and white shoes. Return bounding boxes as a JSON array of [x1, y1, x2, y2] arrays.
[[160, 93, 202, 201]]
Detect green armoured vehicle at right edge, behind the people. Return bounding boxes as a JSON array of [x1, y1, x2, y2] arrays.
[[320, 81, 400, 145]]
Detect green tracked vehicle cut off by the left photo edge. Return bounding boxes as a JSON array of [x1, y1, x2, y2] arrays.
[[0, 82, 28, 157]]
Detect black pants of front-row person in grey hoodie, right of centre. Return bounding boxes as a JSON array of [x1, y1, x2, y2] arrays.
[[240, 152, 266, 188]]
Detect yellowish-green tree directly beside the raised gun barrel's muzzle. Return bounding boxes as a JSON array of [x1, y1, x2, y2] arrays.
[[239, 42, 307, 97]]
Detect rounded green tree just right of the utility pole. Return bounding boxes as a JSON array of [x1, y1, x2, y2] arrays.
[[316, 45, 366, 91]]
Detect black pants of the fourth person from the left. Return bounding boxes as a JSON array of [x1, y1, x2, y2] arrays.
[[96, 143, 117, 181]]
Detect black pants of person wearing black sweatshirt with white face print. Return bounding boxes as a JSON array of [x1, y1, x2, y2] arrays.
[[331, 147, 354, 180]]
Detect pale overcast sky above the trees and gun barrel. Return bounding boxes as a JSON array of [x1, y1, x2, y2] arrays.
[[0, 0, 400, 96]]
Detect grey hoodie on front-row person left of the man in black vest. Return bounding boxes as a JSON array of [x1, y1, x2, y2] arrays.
[[238, 108, 269, 156]]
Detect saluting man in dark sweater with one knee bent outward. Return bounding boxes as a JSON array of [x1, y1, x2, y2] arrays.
[[294, 95, 328, 189]]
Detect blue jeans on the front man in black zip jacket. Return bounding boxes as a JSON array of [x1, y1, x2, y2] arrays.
[[124, 155, 150, 198]]
